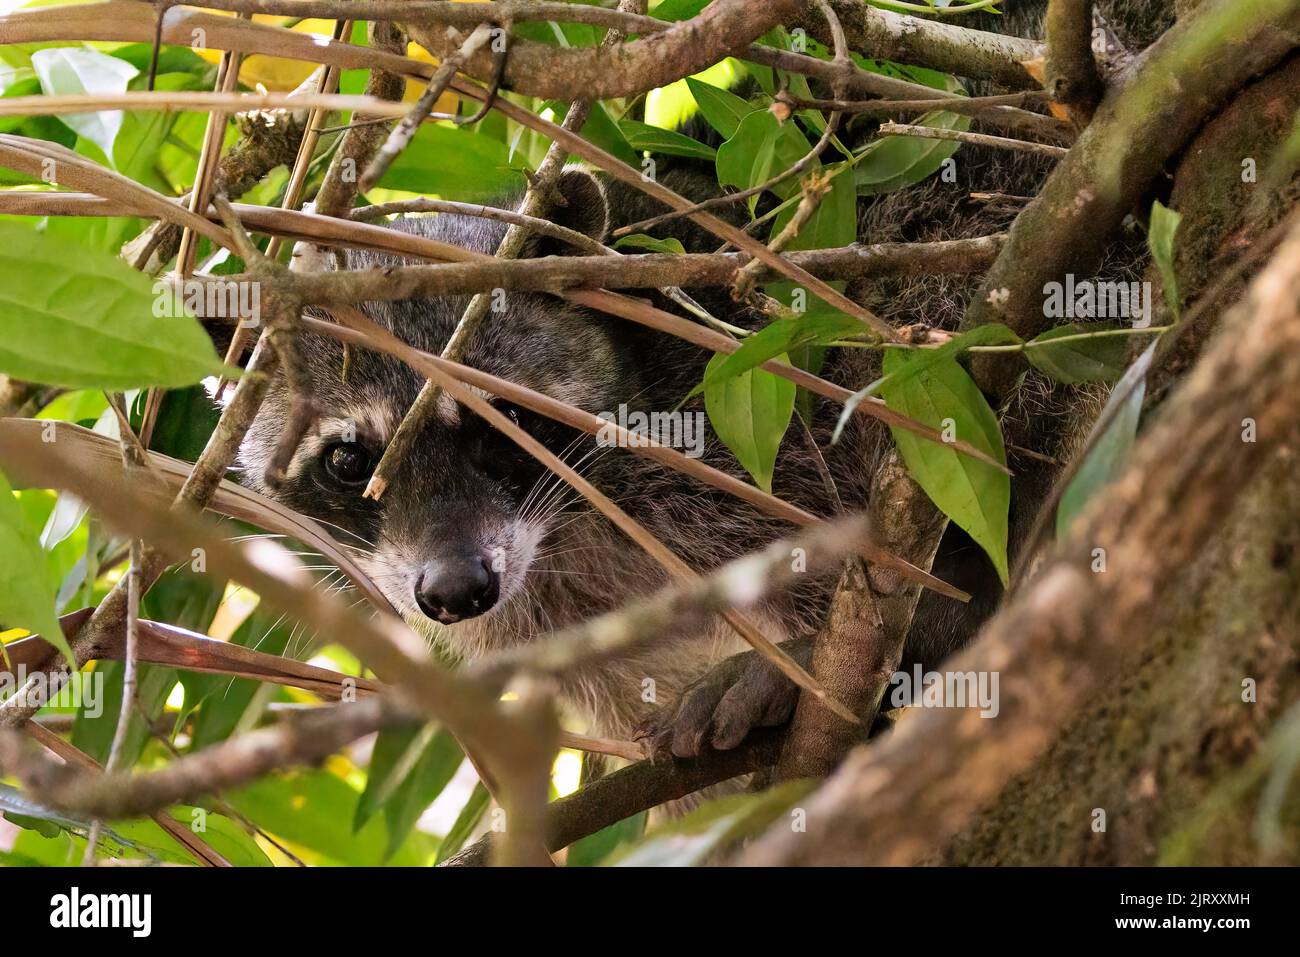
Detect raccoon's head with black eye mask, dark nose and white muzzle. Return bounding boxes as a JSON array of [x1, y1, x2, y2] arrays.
[[239, 174, 655, 642]]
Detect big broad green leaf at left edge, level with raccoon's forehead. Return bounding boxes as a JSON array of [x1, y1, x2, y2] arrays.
[[0, 222, 224, 391]]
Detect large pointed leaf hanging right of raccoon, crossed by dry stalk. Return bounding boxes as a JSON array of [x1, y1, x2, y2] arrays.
[[880, 350, 1011, 583]]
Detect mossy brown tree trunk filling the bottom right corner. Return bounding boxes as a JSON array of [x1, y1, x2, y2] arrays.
[[936, 451, 1300, 865]]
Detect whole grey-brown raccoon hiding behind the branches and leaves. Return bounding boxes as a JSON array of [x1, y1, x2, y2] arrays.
[[239, 0, 1170, 757]]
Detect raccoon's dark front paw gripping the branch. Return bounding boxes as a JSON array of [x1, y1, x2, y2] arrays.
[[633, 638, 813, 758]]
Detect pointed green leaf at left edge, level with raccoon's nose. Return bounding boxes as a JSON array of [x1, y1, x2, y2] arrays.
[[0, 473, 74, 661]]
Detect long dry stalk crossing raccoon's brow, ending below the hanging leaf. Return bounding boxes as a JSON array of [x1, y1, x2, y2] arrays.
[[303, 309, 970, 601]]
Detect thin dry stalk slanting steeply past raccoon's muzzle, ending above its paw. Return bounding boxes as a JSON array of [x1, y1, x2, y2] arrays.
[[318, 309, 857, 720]]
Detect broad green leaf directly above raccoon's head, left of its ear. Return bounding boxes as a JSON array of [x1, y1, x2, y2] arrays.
[[378, 124, 528, 203]]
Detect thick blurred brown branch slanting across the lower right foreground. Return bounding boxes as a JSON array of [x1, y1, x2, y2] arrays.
[[740, 217, 1300, 866]]
